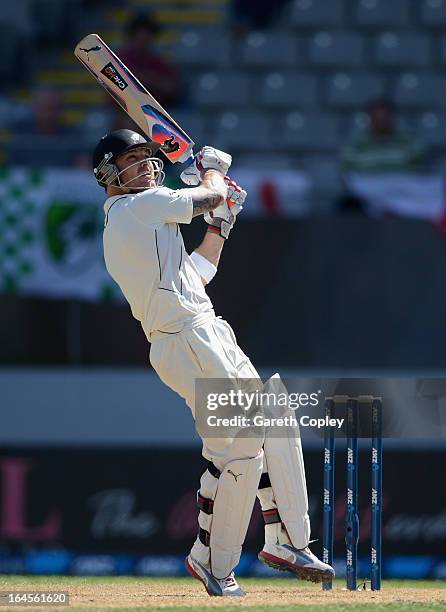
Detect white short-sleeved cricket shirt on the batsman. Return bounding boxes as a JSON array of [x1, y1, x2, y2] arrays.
[[104, 187, 213, 338]]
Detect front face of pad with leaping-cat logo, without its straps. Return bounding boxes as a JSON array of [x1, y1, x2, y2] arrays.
[[210, 451, 263, 580]]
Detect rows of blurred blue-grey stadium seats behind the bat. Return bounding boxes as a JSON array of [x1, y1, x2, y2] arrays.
[[0, 0, 446, 208]]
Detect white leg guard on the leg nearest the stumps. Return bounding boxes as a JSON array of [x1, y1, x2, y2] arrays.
[[259, 374, 310, 549]]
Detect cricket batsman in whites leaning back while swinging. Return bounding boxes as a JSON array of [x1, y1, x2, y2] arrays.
[[93, 130, 334, 596]]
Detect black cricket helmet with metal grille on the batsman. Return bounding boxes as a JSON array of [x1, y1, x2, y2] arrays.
[[93, 130, 163, 189]]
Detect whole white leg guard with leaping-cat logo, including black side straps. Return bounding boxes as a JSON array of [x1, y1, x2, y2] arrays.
[[191, 451, 263, 579]]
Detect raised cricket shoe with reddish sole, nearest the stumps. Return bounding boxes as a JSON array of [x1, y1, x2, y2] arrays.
[[259, 544, 335, 582]]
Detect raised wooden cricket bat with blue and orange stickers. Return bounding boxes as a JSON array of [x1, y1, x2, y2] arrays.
[[74, 34, 195, 163]]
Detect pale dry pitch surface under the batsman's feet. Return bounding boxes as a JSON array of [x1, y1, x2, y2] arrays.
[[0, 576, 446, 612]]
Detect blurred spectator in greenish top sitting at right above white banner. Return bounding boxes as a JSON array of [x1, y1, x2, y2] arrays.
[[338, 98, 426, 211]]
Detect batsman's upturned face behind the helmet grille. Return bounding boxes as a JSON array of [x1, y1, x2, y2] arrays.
[[116, 147, 158, 189]]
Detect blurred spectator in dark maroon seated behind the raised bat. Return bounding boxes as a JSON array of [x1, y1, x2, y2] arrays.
[[113, 15, 181, 129]]
